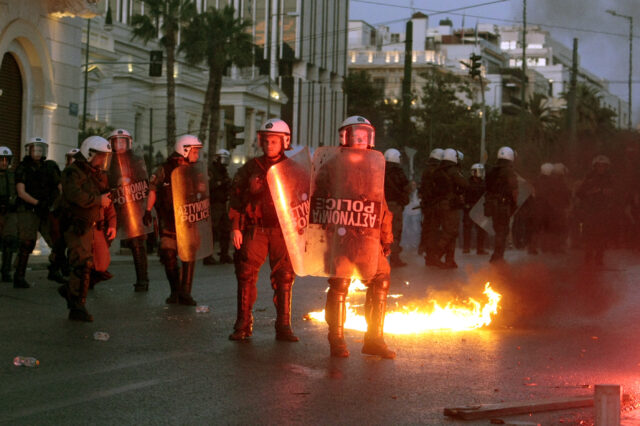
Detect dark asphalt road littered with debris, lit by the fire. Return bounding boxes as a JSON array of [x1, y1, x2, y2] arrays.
[[0, 251, 640, 425]]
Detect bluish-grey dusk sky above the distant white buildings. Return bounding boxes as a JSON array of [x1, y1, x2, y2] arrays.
[[349, 0, 640, 124]]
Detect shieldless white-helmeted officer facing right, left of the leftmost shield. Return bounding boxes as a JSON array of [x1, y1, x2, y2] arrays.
[[58, 136, 116, 322]]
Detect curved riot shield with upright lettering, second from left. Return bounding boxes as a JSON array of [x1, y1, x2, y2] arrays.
[[171, 162, 213, 262]]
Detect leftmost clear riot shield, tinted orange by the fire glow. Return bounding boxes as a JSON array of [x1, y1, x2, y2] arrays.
[[109, 151, 153, 239]]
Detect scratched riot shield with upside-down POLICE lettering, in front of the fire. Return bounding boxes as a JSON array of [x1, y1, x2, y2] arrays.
[[304, 147, 385, 280]]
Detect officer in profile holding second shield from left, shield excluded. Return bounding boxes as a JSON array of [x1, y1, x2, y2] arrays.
[[143, 135, 202, 306]]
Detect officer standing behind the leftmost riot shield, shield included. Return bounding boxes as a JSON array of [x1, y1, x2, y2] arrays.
[[107, 129, 150, 292]]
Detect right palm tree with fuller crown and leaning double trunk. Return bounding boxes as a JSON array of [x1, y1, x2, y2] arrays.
[[180, 5, 254, 158]]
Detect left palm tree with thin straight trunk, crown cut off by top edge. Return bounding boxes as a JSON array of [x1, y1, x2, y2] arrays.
[[131, 0, 197, 152]]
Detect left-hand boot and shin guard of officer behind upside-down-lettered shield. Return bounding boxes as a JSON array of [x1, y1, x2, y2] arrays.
[[325, 278, 350, 358]]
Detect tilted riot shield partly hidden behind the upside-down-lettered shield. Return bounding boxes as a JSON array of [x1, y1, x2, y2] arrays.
[[267, 147, 311, 276]]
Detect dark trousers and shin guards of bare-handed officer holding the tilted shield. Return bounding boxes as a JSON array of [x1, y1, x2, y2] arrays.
[[234, 226, 295, 334]]
